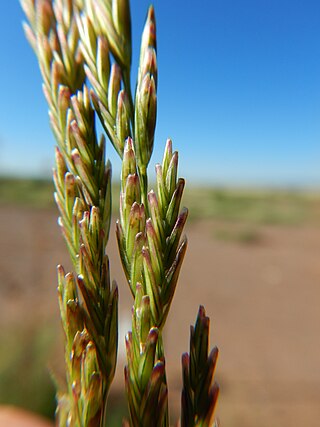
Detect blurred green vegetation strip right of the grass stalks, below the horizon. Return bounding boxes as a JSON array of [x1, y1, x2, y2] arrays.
[[185, 188, 320, 225]]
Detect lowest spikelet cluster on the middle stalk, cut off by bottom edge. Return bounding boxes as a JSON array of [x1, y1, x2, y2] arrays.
[[125, 284, 167, 427]]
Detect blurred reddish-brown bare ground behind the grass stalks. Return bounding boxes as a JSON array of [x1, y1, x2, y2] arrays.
[[0, 207, 320, 427]]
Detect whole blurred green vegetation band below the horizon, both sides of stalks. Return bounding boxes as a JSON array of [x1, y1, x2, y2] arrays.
[[0, 178, 320, 225]]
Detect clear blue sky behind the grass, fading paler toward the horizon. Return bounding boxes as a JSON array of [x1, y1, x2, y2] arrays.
[[0, 0, 320, 186]]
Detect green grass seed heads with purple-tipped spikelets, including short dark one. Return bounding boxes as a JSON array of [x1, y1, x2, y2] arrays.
[[21, 0, 218, 427]]
